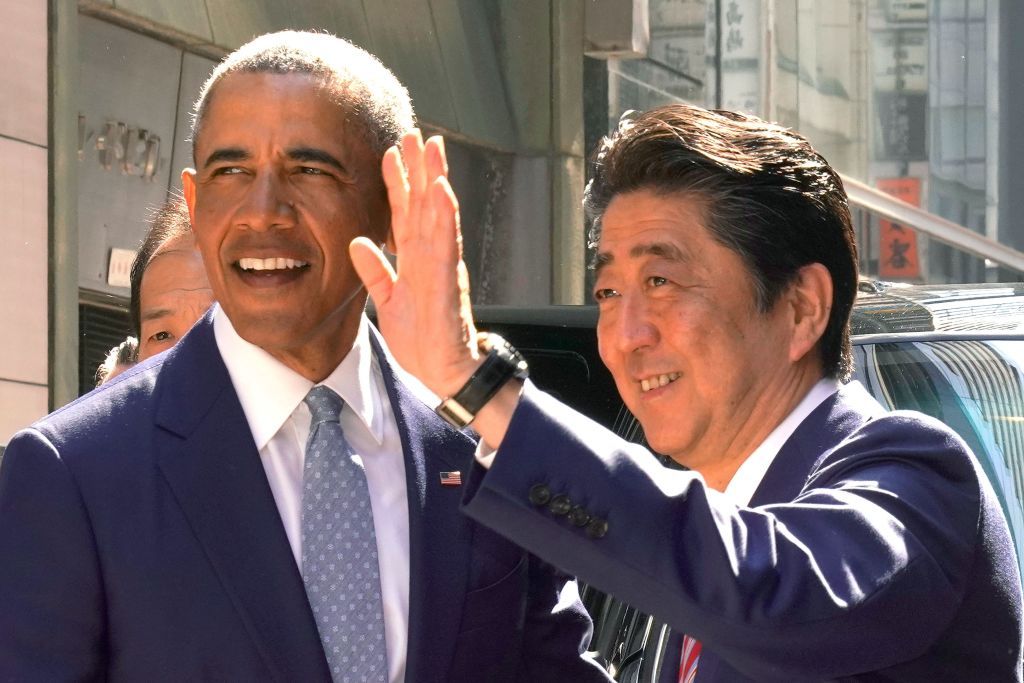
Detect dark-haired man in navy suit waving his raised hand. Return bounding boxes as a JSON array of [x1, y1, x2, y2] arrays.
[[352, 104, 1022, 682]]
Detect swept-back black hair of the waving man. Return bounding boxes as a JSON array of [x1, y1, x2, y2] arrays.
[[584, 104, 858, 380]]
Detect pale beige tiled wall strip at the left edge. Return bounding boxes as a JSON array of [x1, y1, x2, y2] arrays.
[[0, 0, 49, 445]]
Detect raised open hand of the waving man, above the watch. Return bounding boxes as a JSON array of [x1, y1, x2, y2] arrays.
[[349, 130, 479, 397]]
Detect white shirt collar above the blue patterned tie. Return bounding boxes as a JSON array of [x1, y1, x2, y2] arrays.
[[213, 304, 384, 451]]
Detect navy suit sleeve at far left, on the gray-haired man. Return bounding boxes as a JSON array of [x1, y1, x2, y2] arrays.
[[0, 430, 104, 681]]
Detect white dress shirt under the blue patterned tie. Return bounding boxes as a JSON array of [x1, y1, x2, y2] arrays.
[[213, 305, 409, 683]]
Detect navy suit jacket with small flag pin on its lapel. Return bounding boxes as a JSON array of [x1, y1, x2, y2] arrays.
[[0, 316, 605, 683]]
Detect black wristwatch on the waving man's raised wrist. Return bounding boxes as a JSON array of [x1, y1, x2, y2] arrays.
[[434, 332, 529, 429]]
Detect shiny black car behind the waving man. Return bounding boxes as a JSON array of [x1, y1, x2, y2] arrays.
[[474, 281, 1024, 682]]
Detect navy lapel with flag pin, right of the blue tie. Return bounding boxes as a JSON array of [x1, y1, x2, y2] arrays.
[[371, 330, 474, 681]]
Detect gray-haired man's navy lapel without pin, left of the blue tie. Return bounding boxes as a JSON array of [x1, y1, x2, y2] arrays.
[[156, 314, 330, 681]]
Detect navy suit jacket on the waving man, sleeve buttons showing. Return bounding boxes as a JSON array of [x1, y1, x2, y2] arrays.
[[466, 383, 1022, 683]]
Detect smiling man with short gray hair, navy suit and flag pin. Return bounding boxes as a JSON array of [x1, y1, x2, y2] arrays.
[[0, 32, 607, 683]]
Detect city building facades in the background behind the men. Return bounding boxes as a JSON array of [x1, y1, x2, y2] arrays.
[[0, 0, 1024, 446]]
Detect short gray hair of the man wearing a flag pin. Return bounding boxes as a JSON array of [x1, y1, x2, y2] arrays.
[[191, 31, 416, 159]]
